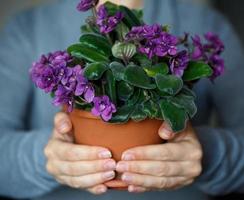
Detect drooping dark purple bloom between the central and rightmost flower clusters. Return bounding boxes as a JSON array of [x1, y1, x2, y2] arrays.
[[170, 50, 190, 77]]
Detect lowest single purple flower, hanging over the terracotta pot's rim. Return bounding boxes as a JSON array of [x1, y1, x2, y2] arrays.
[[91, 95, 116, 121]]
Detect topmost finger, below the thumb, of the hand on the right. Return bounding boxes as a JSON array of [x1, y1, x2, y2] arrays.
[[122, 143, 196, 161]]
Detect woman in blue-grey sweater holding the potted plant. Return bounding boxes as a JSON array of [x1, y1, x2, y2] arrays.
[[0, 0, 244, 200]]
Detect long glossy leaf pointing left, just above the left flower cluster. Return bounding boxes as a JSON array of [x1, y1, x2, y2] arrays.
[[67, 44, 109, 62]]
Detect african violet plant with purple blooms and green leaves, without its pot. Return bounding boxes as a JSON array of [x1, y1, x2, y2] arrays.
[[30, 0, 224, 132]]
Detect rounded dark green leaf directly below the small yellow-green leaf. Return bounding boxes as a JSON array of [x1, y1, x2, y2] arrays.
[[155, 74, 183, 95]]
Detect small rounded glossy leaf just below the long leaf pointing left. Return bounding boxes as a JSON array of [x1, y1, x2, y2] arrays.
[[84, 62, 109, 80]]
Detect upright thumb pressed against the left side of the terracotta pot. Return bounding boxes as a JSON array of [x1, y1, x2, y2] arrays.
[[54, 112, 73, 141]]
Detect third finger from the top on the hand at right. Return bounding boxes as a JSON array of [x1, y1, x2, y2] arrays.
[[122, 173, 188, 189]]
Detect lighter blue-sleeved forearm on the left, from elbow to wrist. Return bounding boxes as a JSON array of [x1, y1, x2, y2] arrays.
[[0, 129, 58, 198]]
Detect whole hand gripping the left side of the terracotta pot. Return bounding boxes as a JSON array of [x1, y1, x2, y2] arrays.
[[44, 113, 116, 194]]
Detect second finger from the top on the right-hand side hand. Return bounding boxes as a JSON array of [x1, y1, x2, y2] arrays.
[[116, 161, 201, 177]]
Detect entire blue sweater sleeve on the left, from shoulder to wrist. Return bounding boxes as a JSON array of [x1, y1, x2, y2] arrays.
[[0, 13, 57, 198]]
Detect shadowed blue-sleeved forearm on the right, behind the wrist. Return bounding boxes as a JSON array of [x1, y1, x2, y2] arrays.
[[196, 127, 244, 195]]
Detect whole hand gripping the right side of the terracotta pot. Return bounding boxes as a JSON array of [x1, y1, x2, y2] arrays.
[[116, 123, 202, 192]]
